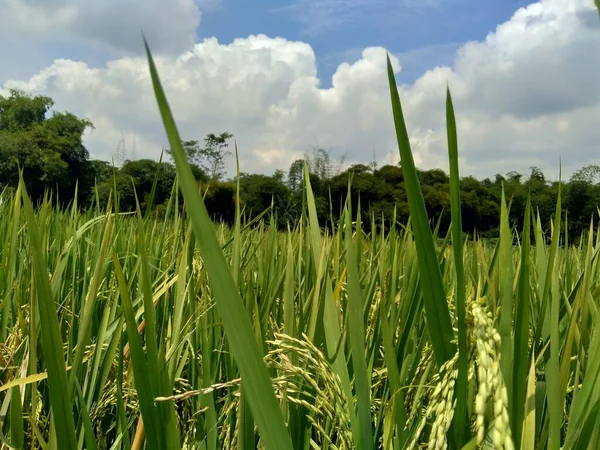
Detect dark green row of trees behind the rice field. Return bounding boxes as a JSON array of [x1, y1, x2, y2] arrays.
[[0, 90, 600, 241]]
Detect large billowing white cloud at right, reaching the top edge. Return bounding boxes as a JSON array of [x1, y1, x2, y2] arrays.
[[403, 0, 600, 178]]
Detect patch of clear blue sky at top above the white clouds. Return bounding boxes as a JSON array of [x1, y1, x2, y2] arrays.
[[197, 0, 531, 87]]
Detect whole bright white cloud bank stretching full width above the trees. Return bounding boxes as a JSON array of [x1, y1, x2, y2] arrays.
[[5, 0, 600, 176]]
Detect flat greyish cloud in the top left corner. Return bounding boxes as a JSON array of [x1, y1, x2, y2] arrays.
[[0, 0, 202, 53]]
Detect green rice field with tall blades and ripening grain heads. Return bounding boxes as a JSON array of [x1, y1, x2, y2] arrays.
[[0, 44, 600, 450]]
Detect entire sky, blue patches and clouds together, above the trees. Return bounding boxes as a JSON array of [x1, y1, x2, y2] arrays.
[[0, 0, 600, 179]]
